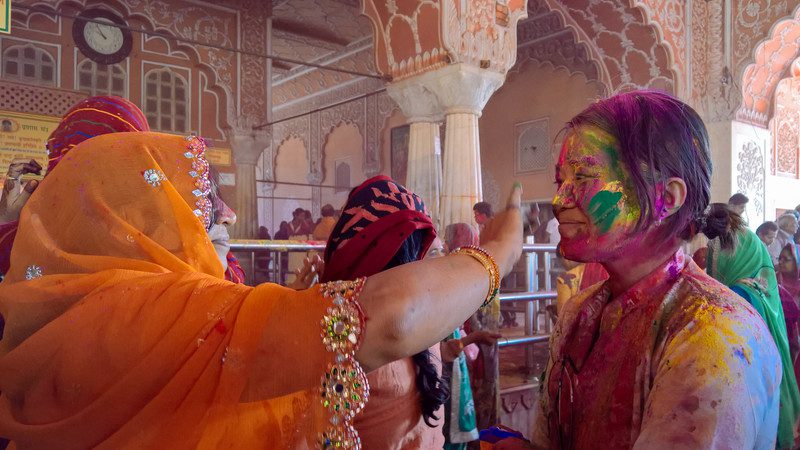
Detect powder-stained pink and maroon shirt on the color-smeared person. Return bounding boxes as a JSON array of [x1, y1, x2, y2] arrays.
[[533, 251, 781, 449]]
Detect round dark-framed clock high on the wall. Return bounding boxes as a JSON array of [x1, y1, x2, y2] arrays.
[[72, 9, 133, 64]]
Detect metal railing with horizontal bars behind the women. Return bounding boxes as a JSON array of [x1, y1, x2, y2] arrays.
[[231, 237, 556, 368]]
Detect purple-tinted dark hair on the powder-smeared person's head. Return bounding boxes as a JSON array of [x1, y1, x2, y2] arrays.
[[566, 90, 712, 239]]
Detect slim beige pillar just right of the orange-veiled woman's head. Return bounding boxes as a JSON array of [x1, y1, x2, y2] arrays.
[[227, 126, 271, 239]]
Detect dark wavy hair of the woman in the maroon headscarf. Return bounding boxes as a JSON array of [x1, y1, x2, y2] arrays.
[[383, 230, 450, 428]]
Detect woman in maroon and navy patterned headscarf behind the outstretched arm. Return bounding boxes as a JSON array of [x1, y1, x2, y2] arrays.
[[321, 176, 448, 450]]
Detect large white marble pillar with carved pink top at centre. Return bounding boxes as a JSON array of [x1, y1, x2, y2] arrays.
[[362, 0, 527, 227]]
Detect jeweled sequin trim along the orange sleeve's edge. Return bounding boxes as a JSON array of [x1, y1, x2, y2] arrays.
[[317, 278, 369, 450]]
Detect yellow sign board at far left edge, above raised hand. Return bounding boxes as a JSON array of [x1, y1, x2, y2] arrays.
[[0, 111, 61, 179]]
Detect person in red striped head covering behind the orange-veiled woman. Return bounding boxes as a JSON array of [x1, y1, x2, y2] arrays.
[[0, 95, 244, 283]]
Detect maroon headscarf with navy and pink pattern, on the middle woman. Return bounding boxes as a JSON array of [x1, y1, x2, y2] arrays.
[[322, 175, 436, 282]]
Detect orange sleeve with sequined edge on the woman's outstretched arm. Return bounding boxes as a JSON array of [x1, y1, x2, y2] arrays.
[[247, 279, 369, 449]]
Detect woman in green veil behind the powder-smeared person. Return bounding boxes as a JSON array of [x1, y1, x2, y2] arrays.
[[703, 203, 800, 448]]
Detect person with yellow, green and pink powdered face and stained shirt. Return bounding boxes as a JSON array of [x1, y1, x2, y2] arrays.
[[495, 90, 781, 450]]
